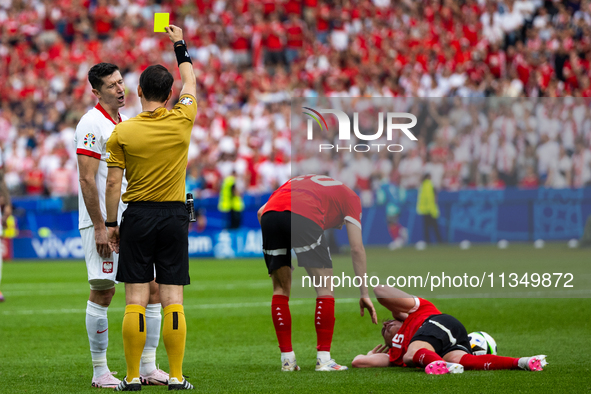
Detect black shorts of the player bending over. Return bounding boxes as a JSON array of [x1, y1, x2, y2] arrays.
[[261, 211, 332, 274]]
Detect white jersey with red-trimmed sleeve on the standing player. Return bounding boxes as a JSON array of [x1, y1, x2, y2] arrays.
[[74, 104, 127, 229]]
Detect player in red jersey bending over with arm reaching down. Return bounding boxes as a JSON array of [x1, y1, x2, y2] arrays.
[[258, 175, 378, 371]]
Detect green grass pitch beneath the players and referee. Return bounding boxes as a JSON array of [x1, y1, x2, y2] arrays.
[[0, 245, 591, 394]]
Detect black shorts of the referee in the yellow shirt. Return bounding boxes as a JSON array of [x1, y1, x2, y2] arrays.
[[117, 201, 190, 285]]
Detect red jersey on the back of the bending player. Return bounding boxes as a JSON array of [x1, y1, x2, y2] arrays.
[[263, 175, 361, 230]]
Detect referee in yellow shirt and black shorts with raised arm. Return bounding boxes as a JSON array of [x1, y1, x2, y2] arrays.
[[105, 25, 197, 391]]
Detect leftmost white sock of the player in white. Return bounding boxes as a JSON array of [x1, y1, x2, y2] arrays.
[[86, 301, 109, 378]]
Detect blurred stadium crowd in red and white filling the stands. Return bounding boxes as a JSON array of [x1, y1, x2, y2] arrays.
[[0, 0, 591, 197]]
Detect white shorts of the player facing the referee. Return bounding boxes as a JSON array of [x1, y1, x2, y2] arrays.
[[80, 226, 119, 290]]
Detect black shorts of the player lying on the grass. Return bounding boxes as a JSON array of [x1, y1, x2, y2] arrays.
[[410, 314, 472, 357]]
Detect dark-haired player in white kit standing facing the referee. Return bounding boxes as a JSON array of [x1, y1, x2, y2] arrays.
[[74, 63, 168, 387]]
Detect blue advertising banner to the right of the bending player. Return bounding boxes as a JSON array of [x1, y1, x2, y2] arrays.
[[336, 188, 591, 245]]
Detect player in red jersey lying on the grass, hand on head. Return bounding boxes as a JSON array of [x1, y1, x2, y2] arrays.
[[352, 286, 547, 375]]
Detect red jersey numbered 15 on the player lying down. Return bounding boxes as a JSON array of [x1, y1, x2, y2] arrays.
[[388, 298, 441, 367]]
